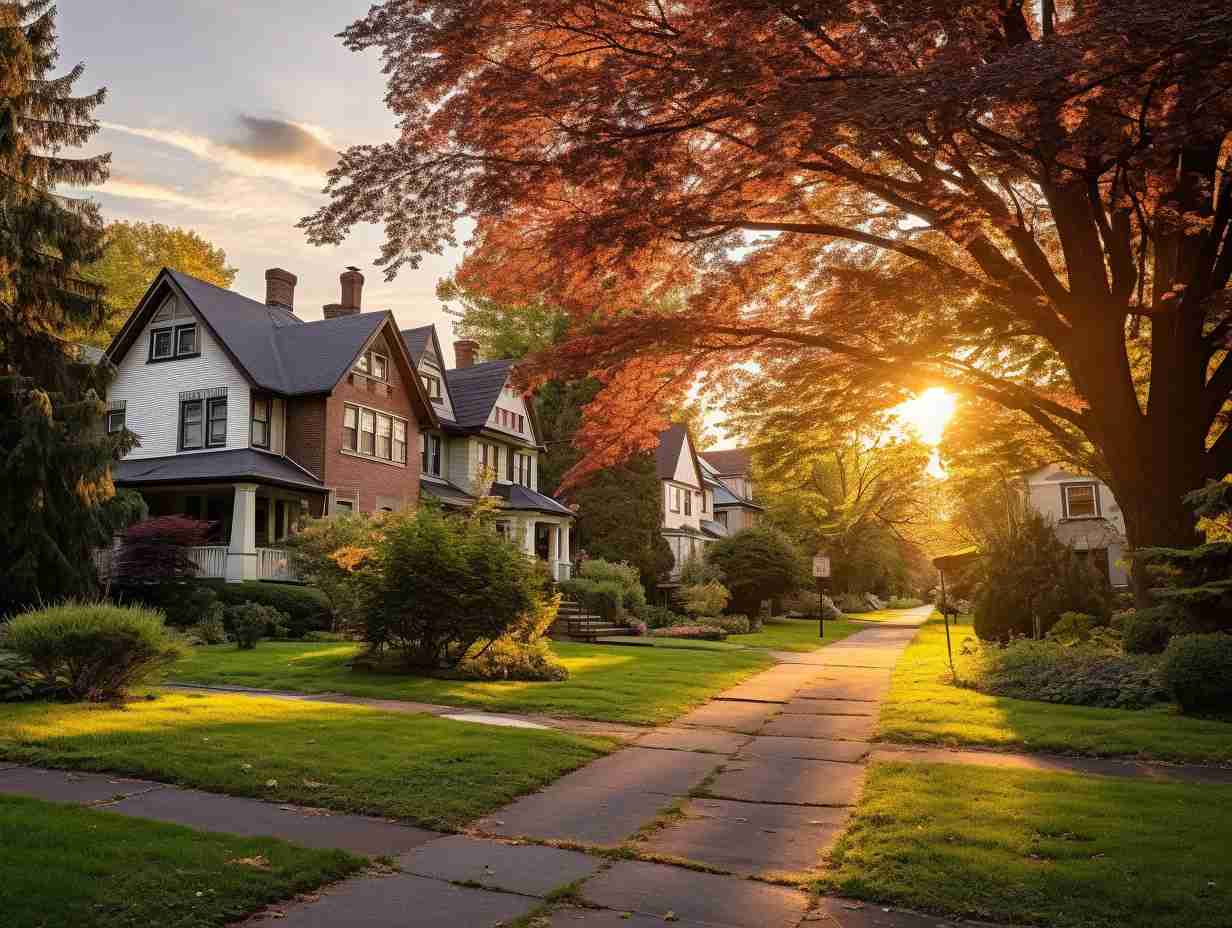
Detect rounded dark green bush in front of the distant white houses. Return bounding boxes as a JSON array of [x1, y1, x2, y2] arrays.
[[706, 526, 808, 615]]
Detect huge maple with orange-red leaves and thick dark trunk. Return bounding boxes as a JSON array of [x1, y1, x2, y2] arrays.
[[302, 0, 1232, 576]]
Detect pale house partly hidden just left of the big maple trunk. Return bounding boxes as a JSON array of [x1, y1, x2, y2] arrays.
[[1023, 465, 1130, 588]]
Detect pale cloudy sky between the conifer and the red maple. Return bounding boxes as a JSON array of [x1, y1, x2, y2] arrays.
[[58, 0, 461, 337]]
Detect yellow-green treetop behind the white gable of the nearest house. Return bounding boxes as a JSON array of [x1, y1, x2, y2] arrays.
[[79, 221, 237, 348]]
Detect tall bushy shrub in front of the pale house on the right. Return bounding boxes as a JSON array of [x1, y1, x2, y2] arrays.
[[975, 511, 1111, 641]]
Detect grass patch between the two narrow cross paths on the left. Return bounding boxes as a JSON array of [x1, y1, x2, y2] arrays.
[[0, 694, 612, 828]]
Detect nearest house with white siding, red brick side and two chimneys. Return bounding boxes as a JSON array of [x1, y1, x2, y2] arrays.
[[105, 267, 440, 580]]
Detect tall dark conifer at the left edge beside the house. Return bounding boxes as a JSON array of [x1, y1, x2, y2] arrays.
[[0, 0, 132, 615]]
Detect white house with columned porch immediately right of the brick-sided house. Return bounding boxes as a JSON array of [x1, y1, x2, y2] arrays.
[[402, 325, 574, 579]]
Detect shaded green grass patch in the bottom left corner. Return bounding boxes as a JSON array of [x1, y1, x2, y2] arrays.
[[0, 796, 363, 928]]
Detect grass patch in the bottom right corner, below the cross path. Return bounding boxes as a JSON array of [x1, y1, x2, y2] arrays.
[[819, 764, 1232, 928]]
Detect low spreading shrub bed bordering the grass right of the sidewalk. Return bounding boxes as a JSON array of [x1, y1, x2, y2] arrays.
[[977, 638, 1168, 709]]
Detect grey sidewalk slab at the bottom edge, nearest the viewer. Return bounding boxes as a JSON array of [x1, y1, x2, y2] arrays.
[[245, 874, 541, 928]]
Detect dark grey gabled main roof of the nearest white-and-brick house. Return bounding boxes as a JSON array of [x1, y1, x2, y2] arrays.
[[107, 267, 435, 421]]
